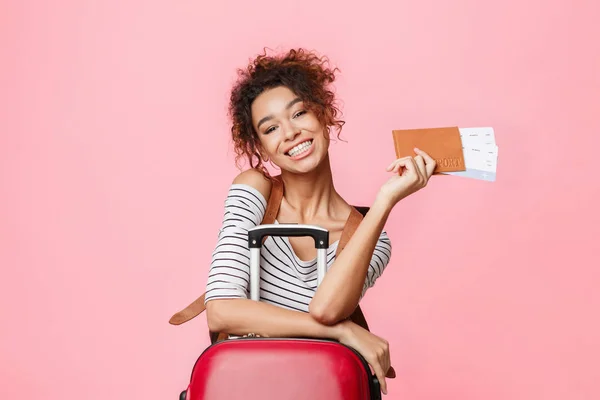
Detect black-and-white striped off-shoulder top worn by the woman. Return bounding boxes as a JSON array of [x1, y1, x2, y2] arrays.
[[205, 184, 391, 312]]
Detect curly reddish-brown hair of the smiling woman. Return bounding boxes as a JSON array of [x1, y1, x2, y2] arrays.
[[229, 48, 345, 177]]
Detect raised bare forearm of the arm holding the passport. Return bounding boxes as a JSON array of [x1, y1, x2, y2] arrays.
[[310, 197, 392, 325]]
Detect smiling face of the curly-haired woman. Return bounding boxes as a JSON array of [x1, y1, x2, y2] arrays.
[[252, 86, 329, 173]]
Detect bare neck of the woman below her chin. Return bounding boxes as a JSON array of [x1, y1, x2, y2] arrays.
[[281, 155, 340, 221]]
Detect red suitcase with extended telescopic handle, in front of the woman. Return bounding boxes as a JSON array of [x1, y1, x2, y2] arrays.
[[180, 224, 381, 400]]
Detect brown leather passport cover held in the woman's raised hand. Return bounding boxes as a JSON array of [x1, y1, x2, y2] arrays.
[[392, 127, 465, 174]]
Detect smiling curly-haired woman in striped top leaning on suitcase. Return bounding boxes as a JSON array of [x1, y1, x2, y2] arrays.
[[205, 49, 435, 393]]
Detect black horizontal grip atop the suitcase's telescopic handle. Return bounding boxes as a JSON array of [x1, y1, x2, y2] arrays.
[[248, 224, 329, 249]]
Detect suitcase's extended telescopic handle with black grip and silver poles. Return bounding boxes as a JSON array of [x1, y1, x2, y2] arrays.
[[248, 224, 329, 301]]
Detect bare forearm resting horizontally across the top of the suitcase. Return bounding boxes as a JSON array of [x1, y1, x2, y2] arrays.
[[206, 299, 341, 340]]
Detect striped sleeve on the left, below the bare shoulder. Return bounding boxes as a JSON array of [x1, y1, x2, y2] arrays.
[[204, 184, 267, 303]]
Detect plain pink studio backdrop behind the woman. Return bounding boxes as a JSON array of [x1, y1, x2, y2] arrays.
[[0, 0, 600, 400]]
